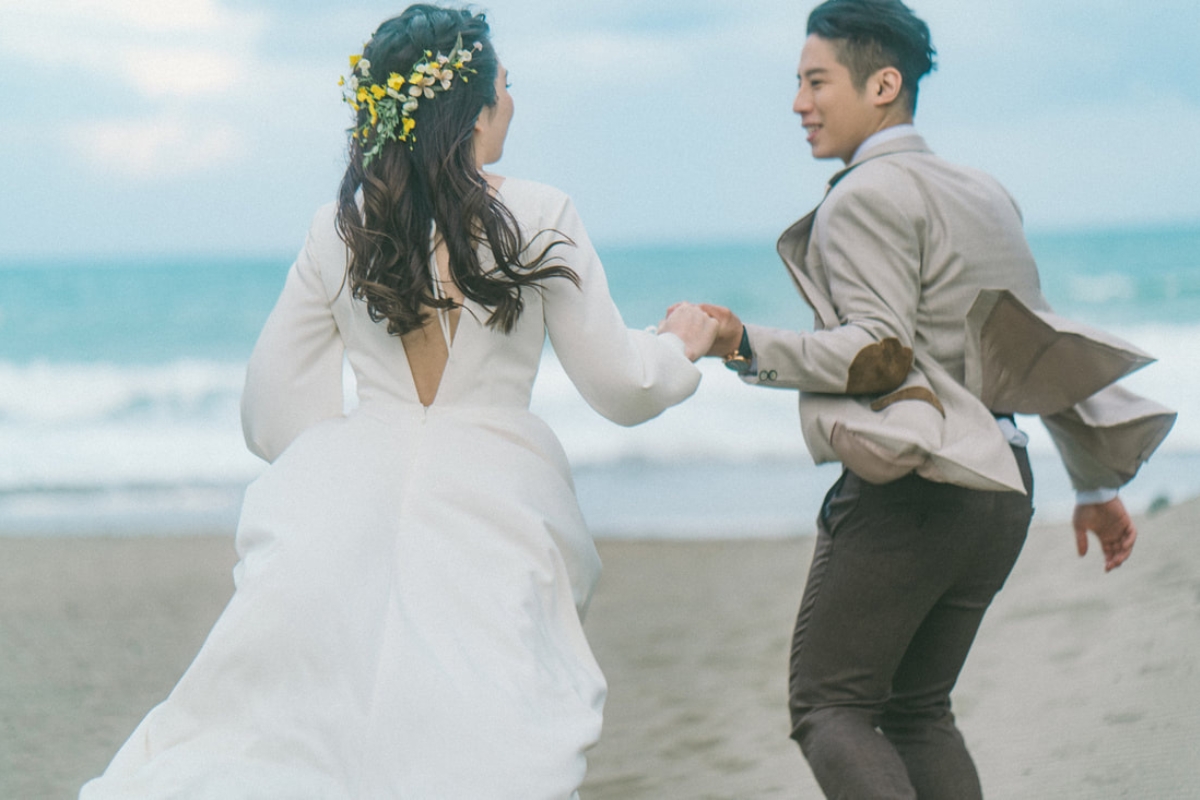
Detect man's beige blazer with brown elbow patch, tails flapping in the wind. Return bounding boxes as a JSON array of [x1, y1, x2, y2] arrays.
[[746, 136, 1175, 492]]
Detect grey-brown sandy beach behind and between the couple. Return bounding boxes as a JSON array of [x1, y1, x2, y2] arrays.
[[0, 501, 1200, 800]]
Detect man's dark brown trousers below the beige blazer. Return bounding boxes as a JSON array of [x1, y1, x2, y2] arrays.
[[790, 447, 1033, 800]]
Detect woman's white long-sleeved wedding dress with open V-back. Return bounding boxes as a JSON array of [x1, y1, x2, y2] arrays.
[[80, 179, 700, 800]]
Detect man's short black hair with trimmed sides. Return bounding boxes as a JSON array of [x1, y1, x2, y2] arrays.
[[808, 0, 937, 112]]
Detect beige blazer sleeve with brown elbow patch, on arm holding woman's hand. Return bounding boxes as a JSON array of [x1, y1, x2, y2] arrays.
[[746, 181, 922, 395]]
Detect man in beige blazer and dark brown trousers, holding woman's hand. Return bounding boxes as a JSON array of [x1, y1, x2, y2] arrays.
[[681, 0, 1174, 800]]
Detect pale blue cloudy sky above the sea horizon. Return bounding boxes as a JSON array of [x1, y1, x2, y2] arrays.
[[0, 0, 1200, 259]]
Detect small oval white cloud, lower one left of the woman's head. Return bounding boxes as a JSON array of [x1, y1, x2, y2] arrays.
[[67, 116, 245, 181]]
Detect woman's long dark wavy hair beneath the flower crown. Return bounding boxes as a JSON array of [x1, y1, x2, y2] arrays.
[[337, 5, 580, 336]]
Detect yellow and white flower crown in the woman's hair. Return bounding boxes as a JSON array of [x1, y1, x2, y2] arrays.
[[337, 34, 484, 167]]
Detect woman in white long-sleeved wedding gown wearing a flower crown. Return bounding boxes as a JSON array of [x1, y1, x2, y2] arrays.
[[80, 5, 715, 800]]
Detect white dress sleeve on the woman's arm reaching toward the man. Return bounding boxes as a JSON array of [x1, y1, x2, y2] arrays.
[[535, 194, 700, 426]]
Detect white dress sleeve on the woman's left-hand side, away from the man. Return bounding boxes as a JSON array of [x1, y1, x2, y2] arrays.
[[241, 207, 344, 462]]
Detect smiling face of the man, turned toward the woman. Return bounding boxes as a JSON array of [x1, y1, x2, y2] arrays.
[[792, 35, 880, 164]]
